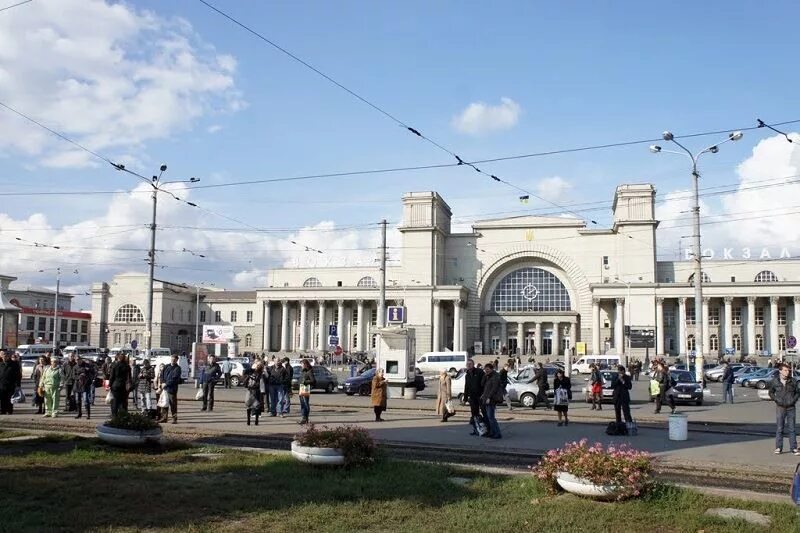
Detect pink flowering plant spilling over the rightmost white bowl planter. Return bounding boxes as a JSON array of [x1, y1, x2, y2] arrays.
[[533, 439, 653, 500]]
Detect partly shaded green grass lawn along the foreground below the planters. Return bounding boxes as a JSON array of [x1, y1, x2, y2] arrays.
[[0, 441, 800, 533]]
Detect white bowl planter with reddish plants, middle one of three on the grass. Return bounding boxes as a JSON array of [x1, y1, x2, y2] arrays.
[[292, 424, 378, 465]]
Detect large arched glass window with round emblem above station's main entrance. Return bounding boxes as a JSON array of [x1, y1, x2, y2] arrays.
[[491, 267, 572, 313]]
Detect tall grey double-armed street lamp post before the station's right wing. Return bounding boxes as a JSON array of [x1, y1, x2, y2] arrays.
[[650, 131, 743, 382]]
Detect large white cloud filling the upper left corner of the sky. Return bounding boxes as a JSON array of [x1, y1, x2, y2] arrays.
[[0, 0, 244, 168]]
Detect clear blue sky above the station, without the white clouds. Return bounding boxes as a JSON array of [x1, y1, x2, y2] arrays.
[[0, 0, 800, 300]]
